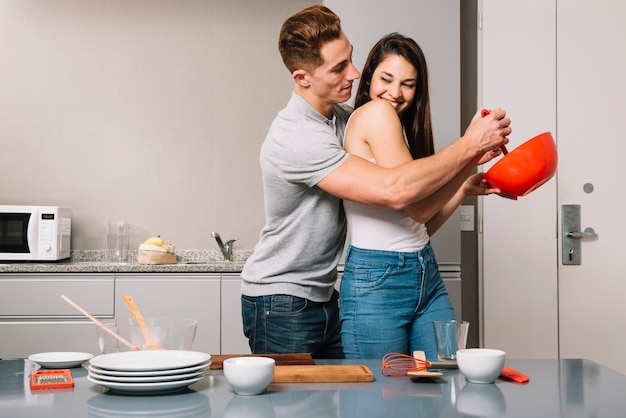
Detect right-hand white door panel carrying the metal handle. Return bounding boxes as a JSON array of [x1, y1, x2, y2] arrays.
[[557, 0, 626, 373]]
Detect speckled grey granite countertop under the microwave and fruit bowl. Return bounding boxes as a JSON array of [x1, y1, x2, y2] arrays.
[[0, 250, 252, 273]]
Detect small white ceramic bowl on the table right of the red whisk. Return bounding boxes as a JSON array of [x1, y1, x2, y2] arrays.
[[456, 348, 506, 383]]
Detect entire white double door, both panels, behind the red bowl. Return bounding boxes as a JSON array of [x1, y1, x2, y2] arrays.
[[480, 0, 626, 373]]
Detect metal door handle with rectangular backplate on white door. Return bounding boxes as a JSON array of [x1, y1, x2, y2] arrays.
[[561, 205, 598, 265]]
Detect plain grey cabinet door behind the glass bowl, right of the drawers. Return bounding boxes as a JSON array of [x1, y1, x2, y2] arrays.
[[115, 274, 221, 353]]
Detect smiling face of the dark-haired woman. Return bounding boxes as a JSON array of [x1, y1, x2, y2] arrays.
[[369, 55, 418, 114]]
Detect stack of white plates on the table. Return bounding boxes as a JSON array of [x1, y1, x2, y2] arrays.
[[87, 350, 211, 394]]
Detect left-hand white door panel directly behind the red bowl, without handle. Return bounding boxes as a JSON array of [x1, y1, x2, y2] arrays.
[[479, 0, 559, 358]]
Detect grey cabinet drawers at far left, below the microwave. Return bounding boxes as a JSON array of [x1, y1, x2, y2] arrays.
[[0, 274, 115, 358]]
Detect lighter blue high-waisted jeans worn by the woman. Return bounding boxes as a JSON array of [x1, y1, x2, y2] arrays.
[[340, 243, 454, 359]]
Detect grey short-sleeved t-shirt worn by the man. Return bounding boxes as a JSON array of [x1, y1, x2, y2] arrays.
[[241, 93, 352, 302]]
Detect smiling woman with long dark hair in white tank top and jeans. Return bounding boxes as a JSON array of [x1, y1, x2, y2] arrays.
[[340, 33, 498, 359]]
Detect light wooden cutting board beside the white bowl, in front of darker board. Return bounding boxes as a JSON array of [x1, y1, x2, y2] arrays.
[[272, 364, 374, 383]]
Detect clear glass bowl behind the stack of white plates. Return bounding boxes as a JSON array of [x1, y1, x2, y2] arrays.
[[96, 318, 198, 354]]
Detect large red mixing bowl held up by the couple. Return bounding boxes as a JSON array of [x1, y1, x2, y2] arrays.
[[485, 132, 558, 197]]
